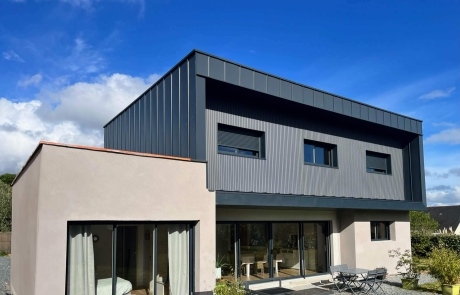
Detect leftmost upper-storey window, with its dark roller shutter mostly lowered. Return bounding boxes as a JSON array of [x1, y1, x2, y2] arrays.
[[217, 124, 265, 158]]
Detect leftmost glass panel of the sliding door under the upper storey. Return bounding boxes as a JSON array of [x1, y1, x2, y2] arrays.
[[216, 224, 237, 281]]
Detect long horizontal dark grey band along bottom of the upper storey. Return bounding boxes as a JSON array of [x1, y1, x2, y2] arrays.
[[216, 191, 426, 211]]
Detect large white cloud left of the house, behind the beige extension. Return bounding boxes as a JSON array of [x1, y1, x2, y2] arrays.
[[0, 74, 159, 174]]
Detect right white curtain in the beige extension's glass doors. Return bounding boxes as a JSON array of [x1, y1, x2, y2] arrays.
[[168, 224, 189, 295]]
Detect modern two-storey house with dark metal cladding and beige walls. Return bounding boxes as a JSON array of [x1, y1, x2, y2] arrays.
[[11, 50, 426, 295]]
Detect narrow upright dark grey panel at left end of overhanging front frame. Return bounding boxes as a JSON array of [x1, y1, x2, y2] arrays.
[[195, 77, 206, 161]]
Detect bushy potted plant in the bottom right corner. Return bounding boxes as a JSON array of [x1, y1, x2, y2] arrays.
[[428, 247, 460, 295]]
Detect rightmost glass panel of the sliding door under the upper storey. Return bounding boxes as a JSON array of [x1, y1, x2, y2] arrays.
[[303, 222, 328, 275]]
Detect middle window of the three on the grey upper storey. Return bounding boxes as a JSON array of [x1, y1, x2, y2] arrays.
[[303, 140, 337, 167]]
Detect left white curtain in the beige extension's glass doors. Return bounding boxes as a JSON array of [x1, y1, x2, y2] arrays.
[[67, 225, 96, 295]]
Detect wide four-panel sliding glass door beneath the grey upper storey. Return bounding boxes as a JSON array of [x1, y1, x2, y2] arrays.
[[216, 222, 329, 282]]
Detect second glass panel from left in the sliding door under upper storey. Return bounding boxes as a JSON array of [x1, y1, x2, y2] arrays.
[[238, 223, 270, 281]]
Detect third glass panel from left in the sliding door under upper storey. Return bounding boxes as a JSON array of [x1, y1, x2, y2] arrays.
[[272, 223, 300, 278]]
